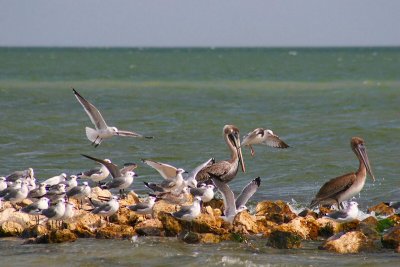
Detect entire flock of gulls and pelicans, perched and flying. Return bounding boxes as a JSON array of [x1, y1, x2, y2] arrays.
[[0, 89, 375, 231]]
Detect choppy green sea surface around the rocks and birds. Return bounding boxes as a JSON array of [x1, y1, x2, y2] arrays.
[[0, 48, 400, 266]]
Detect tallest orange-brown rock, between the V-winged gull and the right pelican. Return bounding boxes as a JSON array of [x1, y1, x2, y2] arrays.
[[256, 200, 297, 223]]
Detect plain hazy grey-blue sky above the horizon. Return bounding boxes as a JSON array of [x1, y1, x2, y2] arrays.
[[0, 0, 400, 47]]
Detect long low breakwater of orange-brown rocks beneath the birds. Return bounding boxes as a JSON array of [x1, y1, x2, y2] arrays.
[[0, 192, 400, 253]]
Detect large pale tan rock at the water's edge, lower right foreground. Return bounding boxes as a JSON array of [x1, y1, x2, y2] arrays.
[[320, 231, 375, 254]]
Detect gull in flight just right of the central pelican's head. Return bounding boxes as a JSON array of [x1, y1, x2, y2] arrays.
[[242, 128, 289, 156]]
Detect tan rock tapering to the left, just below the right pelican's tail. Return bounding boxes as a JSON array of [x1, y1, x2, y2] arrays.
[[271, 216, 319, 240]]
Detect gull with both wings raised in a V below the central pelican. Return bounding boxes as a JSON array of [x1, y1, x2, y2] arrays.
[[210, 174, 261, 223]]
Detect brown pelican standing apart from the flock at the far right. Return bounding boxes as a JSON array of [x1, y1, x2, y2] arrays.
[[310, 137, 375, 211]]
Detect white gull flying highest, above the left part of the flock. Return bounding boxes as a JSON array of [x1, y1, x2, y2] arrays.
[[72, 89, 153, 147]]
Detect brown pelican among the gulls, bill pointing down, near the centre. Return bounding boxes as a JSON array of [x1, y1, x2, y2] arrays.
[[196, 125, 246, 183]]
